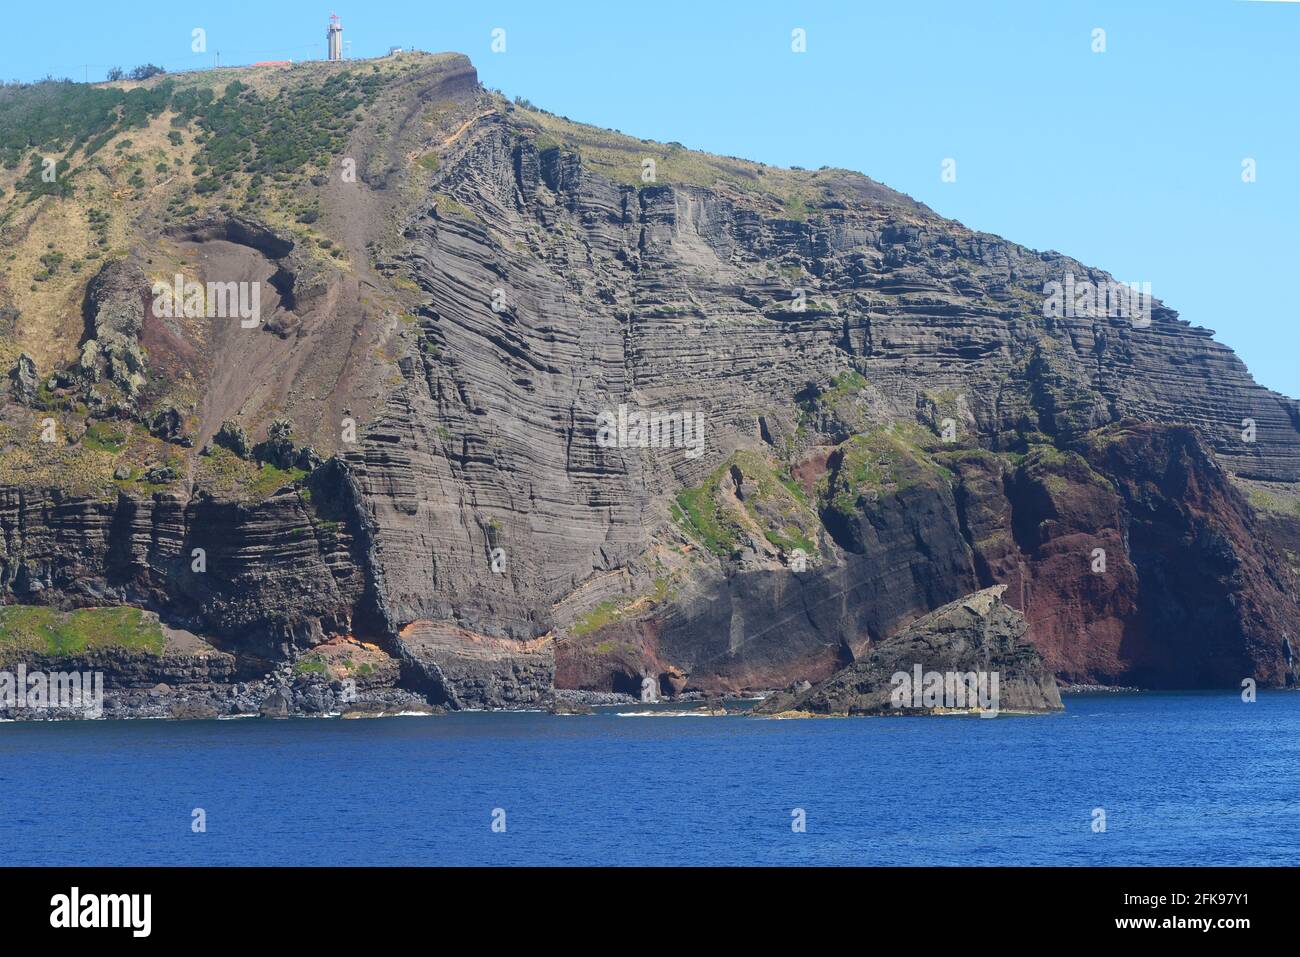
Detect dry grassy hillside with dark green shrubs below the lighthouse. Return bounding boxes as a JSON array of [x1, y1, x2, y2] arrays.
[[0, 57, 419, 373]]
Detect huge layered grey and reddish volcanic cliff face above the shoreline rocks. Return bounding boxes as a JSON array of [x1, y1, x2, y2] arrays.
[[0, 56, 1300, 706]]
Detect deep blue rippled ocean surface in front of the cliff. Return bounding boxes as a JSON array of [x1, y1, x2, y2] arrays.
[[0, 692, 1300, 865]]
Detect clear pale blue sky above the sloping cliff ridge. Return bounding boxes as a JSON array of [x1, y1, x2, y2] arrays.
[[10, 0, 1300, 397]]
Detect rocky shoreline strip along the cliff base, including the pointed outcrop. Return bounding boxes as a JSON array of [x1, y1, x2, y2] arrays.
[[0, 595, 1274, 722]]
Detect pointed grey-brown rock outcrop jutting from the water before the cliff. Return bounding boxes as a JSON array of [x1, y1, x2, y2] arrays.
[[753, 585, 1062, 715]]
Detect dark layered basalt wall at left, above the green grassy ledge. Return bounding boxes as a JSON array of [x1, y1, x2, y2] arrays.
[[0, 475, 373, 658]]
